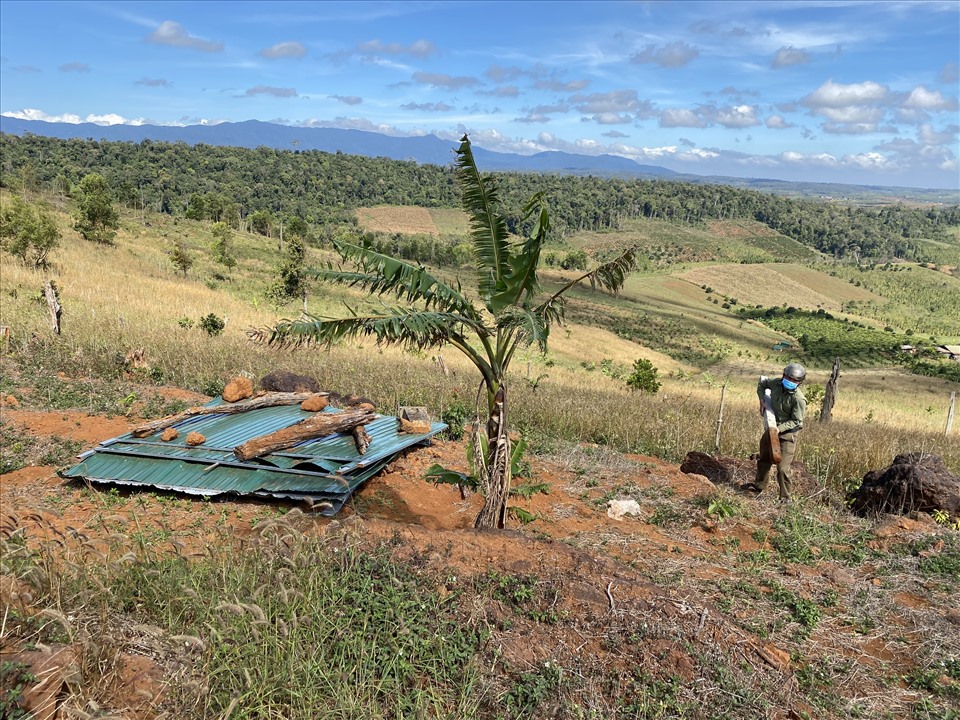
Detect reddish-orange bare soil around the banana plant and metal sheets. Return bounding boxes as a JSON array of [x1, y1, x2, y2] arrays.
[[0, 410, 960, 720]]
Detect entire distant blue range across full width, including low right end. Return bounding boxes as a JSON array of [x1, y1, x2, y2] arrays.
[[0, 115, 955, 202]]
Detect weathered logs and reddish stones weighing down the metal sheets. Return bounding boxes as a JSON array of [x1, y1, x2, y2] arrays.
[[131, 378, 379, 460]]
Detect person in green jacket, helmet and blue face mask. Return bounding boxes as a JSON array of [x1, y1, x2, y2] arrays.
[[744, 363, 807, 502]]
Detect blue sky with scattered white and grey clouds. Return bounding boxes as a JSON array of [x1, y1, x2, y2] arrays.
[[0, 0, 960, 188]]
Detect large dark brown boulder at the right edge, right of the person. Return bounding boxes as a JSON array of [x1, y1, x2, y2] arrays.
[[848, 452, 960, 518]]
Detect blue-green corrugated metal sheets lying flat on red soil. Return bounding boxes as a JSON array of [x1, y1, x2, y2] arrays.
[[59, 398, 447, 516]]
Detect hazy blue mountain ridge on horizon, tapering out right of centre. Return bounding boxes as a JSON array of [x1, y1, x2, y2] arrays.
[[0, 116, 679, 178]]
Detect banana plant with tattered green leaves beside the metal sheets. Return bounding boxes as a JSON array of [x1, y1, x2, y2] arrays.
[[269, 135, 635, 528]]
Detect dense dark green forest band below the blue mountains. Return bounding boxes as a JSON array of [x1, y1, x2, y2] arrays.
[[0, 134, 960, 262]]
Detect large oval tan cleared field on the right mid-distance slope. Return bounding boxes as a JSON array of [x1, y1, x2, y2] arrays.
[[678, 264, 882, 312]]
